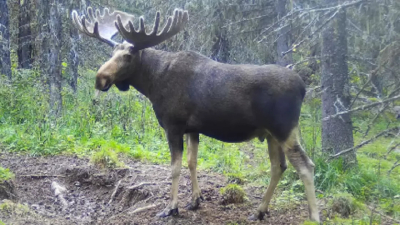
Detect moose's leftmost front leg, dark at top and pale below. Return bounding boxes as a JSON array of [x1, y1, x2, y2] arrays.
[[157, 132, 183, 217]]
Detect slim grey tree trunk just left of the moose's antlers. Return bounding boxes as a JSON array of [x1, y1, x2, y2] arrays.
[[67, 0, 79, 93]]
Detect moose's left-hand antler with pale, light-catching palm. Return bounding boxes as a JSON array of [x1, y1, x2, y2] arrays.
[[72, 7, 138, 47]]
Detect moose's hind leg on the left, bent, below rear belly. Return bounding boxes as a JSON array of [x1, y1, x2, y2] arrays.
[[249, 136, 287, 220]]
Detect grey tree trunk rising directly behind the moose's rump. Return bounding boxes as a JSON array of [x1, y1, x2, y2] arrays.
[[275, 0, 293, 66]]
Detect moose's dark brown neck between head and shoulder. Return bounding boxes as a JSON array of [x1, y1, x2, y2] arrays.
[[130, 48, 173, 98]]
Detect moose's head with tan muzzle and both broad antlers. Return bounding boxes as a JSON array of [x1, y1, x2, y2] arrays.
[[72, 7, 189, 91]]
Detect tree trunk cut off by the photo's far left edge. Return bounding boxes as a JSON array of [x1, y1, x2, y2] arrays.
[[0, 0, 11, 81]]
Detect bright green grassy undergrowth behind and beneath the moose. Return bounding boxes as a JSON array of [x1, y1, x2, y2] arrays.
[[0, 71, 400, 221]]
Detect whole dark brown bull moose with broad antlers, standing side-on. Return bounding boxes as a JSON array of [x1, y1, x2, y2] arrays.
[[72, 7, 320, 222]]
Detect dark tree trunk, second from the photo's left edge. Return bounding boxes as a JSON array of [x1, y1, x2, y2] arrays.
[[17, 0, 33, 69]]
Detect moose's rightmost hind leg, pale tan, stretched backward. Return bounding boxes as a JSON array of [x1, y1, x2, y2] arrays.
[[283, 128, 320, 222]]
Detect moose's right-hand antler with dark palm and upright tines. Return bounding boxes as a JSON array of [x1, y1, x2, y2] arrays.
[[115, 9, 189, 50]]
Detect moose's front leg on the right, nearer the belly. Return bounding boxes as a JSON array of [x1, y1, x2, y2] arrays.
[[186, 133, 202, 210]]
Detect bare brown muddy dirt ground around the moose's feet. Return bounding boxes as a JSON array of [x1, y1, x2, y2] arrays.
[[0, 152, 308, 225]]
